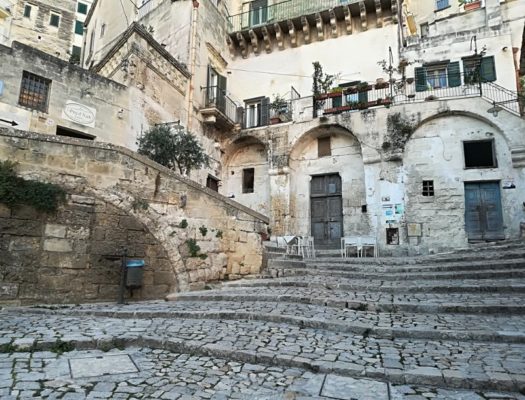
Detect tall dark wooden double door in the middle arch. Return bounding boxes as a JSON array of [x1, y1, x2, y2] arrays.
[[310, 174, 343, 248]]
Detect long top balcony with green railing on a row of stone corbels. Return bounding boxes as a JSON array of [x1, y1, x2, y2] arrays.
[[228, 0, 398, 56]]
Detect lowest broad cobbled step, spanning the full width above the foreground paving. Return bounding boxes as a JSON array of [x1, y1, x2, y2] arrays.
[[1, 305, 525, 392]]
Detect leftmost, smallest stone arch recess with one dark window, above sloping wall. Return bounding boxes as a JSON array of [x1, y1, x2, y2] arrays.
[[221, 135, 270, 215]]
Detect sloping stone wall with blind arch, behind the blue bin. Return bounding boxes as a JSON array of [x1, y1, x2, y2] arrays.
[[0, 129, 268, 302]]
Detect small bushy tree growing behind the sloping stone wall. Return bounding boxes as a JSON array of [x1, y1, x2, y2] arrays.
[[137, 125, 210, 175]]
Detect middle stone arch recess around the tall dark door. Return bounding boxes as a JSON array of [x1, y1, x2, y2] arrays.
[[289, 124, 369, 241]]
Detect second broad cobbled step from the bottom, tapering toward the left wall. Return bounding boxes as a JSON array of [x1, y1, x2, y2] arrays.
[[20, 294, 525, 344]]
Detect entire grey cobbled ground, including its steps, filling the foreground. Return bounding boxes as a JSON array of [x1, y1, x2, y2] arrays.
[[0, 245, 525, 400]]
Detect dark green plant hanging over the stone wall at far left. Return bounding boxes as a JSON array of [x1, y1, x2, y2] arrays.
[[0, 160, 66, 212]]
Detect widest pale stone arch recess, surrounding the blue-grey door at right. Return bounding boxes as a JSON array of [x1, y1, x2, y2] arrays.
[[403, 111, 522, 252]]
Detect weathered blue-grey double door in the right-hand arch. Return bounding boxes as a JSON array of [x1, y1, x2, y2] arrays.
[[465, 182, 505, 240]]
